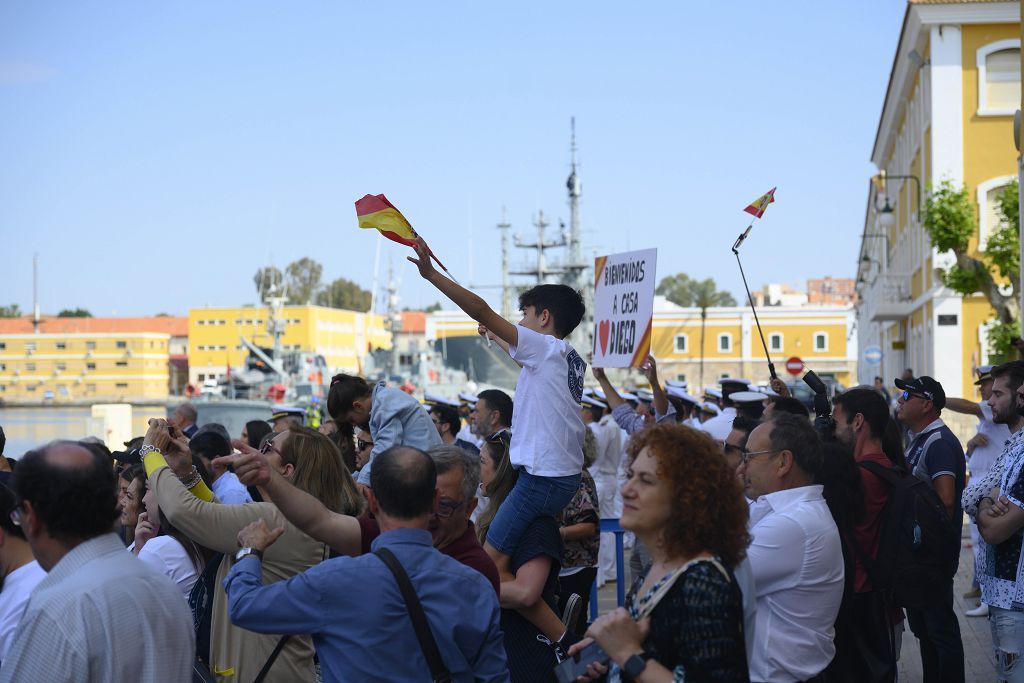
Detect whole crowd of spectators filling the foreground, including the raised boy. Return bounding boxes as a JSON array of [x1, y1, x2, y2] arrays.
[[0, 244, 999, 683]]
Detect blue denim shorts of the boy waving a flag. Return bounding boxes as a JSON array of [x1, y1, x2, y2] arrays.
[[487, 470, 582, 556]]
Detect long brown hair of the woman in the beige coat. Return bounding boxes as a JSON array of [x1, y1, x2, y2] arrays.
[[281, 427, 367, 517]]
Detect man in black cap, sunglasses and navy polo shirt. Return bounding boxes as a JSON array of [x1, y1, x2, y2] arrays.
[[896, 376, 967, 682]]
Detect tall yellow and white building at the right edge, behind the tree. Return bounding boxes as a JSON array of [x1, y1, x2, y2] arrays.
[[857, 0, 1021, 397]]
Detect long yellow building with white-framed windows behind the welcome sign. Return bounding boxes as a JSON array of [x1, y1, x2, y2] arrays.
[[426, 296, 857, 389]]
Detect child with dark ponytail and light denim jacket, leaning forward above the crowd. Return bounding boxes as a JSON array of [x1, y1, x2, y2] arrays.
[[327, 375, 441, 486]]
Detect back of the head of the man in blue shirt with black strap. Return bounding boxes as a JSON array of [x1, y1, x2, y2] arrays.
[[370, 445, 437, 519]]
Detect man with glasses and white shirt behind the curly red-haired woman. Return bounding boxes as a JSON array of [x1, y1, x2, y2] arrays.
[[738, 414, 844, 683]]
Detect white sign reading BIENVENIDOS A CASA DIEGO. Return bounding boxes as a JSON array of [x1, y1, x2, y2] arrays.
[[594, 249, 657, 368]]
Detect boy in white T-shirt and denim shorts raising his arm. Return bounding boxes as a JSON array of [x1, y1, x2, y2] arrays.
[[409, 240, 587, 639]]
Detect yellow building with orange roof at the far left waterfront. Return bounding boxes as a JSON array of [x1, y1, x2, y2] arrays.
[[0, 317, 186, 402]]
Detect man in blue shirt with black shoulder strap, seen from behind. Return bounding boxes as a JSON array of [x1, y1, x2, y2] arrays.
[[224, 446, 509, 682]]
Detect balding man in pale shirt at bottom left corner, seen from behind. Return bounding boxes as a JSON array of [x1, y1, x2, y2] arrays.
[[0, 441, 196, 683]]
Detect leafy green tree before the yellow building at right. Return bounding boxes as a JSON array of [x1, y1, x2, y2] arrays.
[[922, 180, 1021, 359]]
